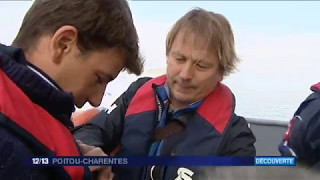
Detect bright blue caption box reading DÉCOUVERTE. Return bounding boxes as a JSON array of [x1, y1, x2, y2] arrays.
[[255, 156, 296, 166]]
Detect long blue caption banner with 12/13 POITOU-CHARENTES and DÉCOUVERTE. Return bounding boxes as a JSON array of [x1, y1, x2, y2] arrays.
[[29, 156, 296, 166]]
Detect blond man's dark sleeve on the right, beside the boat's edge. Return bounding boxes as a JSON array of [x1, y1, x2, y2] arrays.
[[220, 115, 256, 156]]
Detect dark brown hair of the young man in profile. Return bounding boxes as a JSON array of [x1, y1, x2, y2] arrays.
[[13, 0, 143, 75]]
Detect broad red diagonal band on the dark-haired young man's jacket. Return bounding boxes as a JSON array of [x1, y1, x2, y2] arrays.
[[0, 69, 84, 180]]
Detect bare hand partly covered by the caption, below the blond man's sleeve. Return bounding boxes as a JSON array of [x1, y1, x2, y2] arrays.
[[77, 141, 113, 180]]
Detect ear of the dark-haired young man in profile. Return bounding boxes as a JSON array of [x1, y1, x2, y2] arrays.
[[50, 25, 78, 64]]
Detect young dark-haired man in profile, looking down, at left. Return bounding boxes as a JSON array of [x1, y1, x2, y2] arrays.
[[0, 0, 143, 180]]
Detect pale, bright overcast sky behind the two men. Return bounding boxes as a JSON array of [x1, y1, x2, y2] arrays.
[[0, 1, 320, 119]]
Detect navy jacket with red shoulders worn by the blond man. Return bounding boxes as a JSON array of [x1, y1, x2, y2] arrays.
[[74, 76, 255, 180]]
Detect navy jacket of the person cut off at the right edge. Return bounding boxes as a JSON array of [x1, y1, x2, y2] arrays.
[[279, 83, 320, 168]]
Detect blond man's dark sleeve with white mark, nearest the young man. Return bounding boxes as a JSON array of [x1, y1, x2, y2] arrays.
[[73, 78, 151, 154]]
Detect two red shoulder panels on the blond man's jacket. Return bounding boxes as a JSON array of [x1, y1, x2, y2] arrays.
[[126, 75, 234, 133]]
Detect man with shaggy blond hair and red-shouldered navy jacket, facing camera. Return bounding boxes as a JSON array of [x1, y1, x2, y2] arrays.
[[74, 8, 256, 180]]
